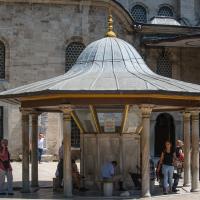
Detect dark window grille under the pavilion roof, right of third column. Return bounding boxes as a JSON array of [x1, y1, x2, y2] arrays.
[[71, 118, 80, 147]]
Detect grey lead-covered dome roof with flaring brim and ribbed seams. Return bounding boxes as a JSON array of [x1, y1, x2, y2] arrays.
[[1, 37, 200, 95]]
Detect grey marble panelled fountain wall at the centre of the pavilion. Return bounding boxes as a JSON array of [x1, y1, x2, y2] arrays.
[[81, 133, 140, 186]]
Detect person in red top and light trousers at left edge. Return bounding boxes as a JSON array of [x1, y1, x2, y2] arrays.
[[0, 139, 13, 195]]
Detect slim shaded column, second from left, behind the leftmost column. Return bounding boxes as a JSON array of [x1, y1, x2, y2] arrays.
[[31, 112, 39, 187]]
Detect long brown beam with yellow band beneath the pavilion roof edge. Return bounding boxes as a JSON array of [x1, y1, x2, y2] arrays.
[[19, 94, 200, 108]]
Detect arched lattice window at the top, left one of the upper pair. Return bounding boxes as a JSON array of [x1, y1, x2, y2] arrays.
[[131, 5, 147, 23]]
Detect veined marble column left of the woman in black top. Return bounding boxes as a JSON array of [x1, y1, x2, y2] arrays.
[[140, 106, 152, 197]]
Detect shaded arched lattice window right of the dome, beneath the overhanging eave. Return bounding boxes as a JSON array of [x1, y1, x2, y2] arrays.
[[156, 52, 172, 78]]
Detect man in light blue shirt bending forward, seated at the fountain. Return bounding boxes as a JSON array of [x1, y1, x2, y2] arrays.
[[101, 161, 124, 191]]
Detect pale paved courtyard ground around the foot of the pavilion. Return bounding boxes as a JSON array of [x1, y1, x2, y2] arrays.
[[1, 162, 200, 200]]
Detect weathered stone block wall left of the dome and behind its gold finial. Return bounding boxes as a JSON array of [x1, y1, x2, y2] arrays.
[[0, 1, 132, 88]]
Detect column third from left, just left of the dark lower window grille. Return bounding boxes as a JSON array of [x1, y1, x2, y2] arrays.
[[63, 110, 72, 197]]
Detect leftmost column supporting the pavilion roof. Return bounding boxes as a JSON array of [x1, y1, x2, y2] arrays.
[[21, 109, 30, 193]]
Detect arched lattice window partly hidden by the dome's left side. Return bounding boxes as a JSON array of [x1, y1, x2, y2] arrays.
[[65, 42, 85, 72]]
